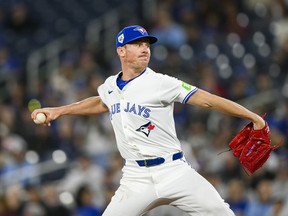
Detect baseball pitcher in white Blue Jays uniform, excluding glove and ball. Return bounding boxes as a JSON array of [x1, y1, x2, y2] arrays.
[[31, 25, 274, 216]]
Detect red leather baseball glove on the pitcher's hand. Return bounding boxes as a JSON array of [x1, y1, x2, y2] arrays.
[[229, 119, 280, 174]]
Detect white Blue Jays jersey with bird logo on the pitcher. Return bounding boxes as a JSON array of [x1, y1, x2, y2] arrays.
[[98, 67, 198, 160]]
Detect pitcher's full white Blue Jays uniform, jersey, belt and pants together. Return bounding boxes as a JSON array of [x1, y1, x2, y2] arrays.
[[98, 68, 234, 216]]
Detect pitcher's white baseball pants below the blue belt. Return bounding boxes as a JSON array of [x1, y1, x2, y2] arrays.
[[103, 156, 234, 216]]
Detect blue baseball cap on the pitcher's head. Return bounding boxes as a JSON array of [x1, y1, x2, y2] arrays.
[[116, 25, 158, 48]]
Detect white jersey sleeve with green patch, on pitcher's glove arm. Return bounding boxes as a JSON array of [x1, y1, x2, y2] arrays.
[[160, 75, 198, 104]]
